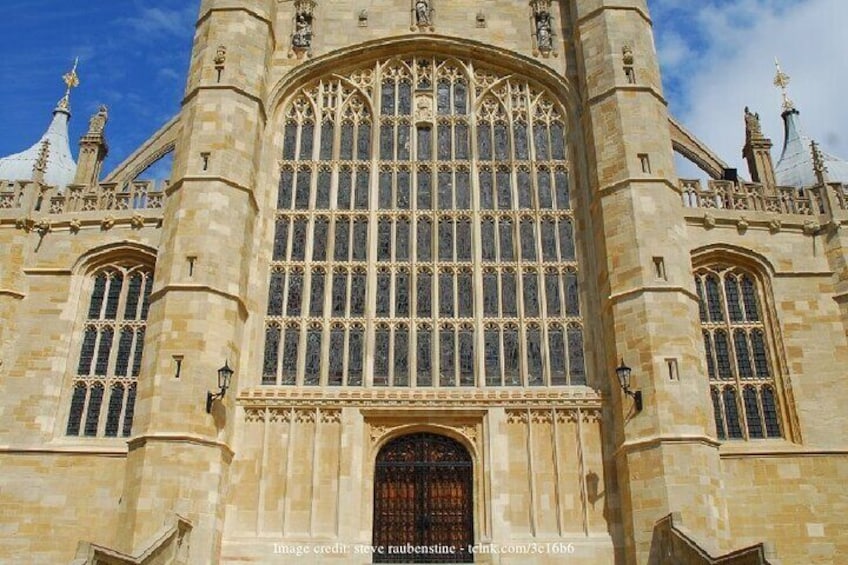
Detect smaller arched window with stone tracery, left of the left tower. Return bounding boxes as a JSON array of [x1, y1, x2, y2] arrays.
[[65, 264, 153, 437]]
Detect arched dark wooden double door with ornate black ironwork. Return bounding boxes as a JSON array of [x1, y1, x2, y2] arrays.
[[373, 433, 474, 563]]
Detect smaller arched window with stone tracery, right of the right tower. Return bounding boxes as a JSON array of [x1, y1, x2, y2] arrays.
[[695, 265, 784, 439]]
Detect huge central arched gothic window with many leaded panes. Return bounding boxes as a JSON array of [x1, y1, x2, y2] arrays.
[[262, 58, 586, 387]]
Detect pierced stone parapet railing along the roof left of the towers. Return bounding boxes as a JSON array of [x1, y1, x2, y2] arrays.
[[0, 180, 168, 215]]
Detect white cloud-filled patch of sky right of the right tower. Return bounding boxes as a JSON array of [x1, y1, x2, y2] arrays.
[[651, 0, 848, 177]]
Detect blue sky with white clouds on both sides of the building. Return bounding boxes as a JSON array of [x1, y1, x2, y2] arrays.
[[0, 0, 848, 181]]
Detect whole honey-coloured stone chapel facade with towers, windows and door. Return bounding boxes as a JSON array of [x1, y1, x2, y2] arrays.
[[0, 0, 848, 564]]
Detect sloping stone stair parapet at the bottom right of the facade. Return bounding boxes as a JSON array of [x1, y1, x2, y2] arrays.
[[648, 512, 774, 565]]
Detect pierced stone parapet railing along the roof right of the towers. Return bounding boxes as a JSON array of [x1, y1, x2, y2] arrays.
[[680, 180, 832, 216]]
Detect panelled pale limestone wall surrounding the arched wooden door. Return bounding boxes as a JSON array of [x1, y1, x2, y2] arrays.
[[222, 400, 613, 563]]
